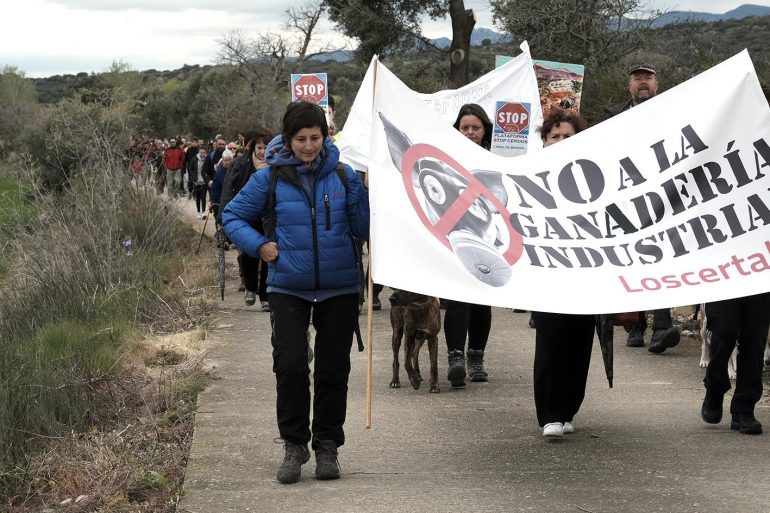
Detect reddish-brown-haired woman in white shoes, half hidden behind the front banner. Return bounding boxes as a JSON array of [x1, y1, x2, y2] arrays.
[[532, 108, 596, 438]]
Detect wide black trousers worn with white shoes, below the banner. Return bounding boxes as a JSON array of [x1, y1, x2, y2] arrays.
[[532, 312, 596, 427]]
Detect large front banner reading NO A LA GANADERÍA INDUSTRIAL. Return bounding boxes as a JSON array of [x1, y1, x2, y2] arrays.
[[369, 51, 770, 313]]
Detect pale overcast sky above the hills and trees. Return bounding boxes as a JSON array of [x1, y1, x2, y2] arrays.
[[0, 0, 770, 77]]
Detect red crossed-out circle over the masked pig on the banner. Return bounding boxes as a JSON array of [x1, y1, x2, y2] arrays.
[[401, 144, 524, 265]]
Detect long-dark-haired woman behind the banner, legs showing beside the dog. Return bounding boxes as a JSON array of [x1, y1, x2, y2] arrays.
[[444, 103, 492, 388]]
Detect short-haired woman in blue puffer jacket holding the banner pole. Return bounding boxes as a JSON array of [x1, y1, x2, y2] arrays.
[[222, 102, 369, 483]]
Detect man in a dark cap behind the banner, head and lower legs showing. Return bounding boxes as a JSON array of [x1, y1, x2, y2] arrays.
[[605, 63, 680, 353]]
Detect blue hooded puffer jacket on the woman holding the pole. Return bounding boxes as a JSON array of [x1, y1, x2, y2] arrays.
[[222, 135, 369, 300]]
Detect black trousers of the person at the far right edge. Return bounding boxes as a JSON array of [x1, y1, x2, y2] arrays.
[[703, 292, 770, 413]]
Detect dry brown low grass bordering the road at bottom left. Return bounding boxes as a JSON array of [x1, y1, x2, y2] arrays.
[[0, 325, 213, 513]]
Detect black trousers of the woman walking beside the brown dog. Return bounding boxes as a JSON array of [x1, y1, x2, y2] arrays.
[[444, 299, 492, 352]]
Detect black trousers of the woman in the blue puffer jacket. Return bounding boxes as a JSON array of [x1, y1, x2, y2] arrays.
[[268, 293, 358, 448]]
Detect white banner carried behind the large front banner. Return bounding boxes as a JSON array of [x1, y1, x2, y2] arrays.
[[336, 42, 543, 171]]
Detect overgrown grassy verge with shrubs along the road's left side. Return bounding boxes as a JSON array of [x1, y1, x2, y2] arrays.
[[0, 156, 215, 512]]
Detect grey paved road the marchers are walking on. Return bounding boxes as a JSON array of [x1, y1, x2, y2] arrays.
[[180, 197, 770, 513]]
